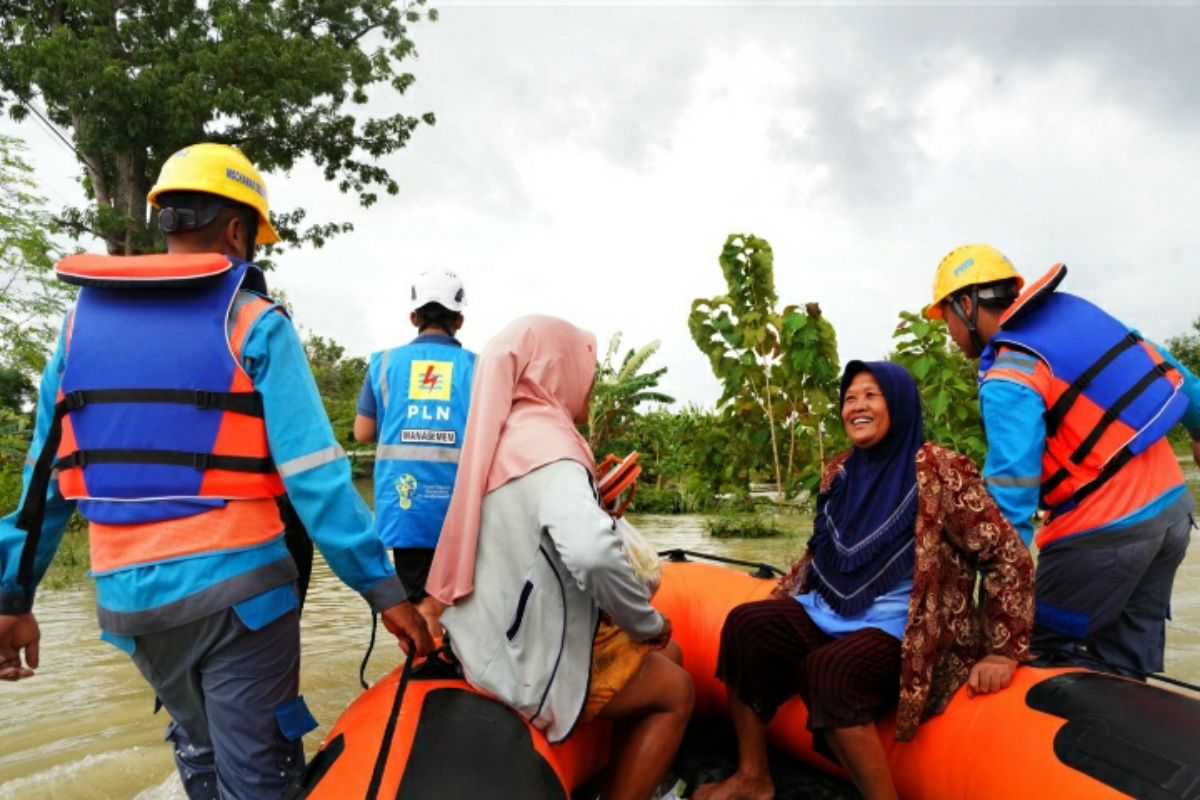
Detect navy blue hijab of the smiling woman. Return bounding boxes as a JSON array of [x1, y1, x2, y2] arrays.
[[808, 361, 925, 616]]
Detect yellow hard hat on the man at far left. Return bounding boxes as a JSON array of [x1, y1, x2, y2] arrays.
[[146, 143, 280, 245]]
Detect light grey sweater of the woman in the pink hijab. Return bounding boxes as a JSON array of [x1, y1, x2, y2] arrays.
[[442, 461, 662, 742]]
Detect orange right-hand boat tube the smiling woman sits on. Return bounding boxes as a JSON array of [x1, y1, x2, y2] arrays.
[[654, 563, 1200, 800]]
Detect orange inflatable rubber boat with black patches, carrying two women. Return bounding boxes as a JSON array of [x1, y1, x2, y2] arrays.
[[292, 563, 1200, 800]]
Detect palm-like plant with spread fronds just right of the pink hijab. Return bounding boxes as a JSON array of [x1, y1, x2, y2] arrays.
[[588, 331, 674, 458]]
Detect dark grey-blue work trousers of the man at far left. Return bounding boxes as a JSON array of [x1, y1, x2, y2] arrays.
[[133, 609, 314, 800]]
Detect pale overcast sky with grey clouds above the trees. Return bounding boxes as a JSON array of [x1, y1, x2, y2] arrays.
[[0, 2, 1200, 404]]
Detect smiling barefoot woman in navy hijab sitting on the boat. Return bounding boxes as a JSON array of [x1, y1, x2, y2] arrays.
[[695, 361, 1033, 800]]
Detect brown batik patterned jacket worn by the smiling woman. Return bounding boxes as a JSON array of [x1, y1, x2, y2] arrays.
[[774, 443, 1033, 741]]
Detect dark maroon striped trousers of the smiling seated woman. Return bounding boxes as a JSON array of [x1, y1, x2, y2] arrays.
[[716, 597, 900, 739]]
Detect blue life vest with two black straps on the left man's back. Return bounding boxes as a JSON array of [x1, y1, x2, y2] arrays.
[[56, 255, 283, 524]]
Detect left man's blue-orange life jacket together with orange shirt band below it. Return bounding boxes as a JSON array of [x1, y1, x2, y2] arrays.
[[18, 254, 295, 583]]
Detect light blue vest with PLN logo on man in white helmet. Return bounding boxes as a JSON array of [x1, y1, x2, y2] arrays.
[[368, 341, 475, 547]]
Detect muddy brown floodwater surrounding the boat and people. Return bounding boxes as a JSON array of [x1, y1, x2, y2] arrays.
[[0, 463, 1200, 800]]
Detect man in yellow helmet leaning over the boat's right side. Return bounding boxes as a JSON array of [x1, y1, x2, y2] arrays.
[[925, 243, 1200, 679]]
